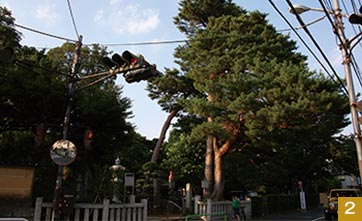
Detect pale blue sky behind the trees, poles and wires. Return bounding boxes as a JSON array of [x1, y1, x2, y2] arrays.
[[0, 0, 361, 139]]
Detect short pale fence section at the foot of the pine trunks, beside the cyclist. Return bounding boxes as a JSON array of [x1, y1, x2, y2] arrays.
[[194, 196, 252, 220]]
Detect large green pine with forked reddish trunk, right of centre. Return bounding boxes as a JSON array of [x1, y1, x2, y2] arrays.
[[176, 6, 348, 199]]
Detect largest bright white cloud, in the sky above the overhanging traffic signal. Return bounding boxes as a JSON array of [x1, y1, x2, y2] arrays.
[[94, 0, 160, 34]]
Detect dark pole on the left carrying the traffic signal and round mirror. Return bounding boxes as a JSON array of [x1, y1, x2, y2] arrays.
[[52, 36, 82, 221]]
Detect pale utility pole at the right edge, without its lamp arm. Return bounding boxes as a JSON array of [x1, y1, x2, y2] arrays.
[[333, 0, 362, 183]]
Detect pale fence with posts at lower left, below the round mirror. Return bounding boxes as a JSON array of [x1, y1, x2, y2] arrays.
[[34, 197, 147, 221]]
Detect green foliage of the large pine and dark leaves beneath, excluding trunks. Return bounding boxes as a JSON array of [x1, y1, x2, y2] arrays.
[[168, 1, 349, 196]]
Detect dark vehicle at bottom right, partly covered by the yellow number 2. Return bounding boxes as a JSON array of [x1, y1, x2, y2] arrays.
[[324, 189, 361, 220]]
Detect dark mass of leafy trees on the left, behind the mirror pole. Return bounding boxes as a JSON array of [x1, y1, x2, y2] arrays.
[[0, 8, 148, 200]]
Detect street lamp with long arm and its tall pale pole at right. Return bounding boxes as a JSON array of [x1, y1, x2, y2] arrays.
[[289, 0, 362, 186]]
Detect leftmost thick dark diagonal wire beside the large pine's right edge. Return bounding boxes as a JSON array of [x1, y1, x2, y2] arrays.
[[268, 0, 348, 96]]
